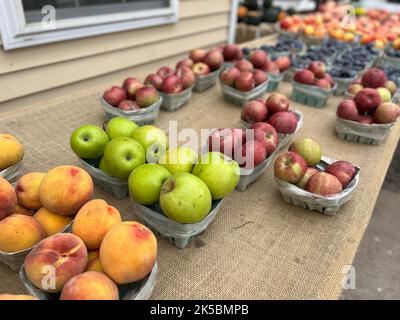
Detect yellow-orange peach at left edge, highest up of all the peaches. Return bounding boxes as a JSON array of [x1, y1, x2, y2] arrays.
[[0, 134, 24, 171]]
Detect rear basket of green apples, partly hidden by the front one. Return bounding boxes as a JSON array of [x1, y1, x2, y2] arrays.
[[70, 117, 168, 199]]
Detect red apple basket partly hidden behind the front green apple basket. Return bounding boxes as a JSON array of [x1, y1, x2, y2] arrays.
[[206, 127, 279, 191]]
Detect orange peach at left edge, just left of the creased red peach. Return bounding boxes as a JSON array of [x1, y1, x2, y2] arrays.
[[0, 214, 45, 253]]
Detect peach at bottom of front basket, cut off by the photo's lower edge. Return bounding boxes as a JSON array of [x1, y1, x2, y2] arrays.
[[60, 271, 119, 300]]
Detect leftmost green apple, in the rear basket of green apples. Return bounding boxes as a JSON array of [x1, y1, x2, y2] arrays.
[[70, 124, 110, 159]]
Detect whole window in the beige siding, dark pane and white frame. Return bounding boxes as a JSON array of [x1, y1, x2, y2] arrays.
[[0, 0, 179, 49]]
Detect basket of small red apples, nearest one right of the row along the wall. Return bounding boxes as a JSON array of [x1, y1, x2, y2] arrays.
[[220, 60, 268, 107]]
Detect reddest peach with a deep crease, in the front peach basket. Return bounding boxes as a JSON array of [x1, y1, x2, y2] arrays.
[[25, 233, 87, 293]]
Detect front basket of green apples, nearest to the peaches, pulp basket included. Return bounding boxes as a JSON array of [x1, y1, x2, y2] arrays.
[[129, 147, 239, 249]]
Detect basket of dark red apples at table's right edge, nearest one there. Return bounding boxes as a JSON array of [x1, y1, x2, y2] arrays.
[[336, 88, 400, 145]]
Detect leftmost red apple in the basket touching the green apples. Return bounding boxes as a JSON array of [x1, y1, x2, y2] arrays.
[[208, 129, 246, 158]]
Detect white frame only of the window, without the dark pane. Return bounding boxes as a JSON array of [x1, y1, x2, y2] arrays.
[[0, 0, 179, 50]]
